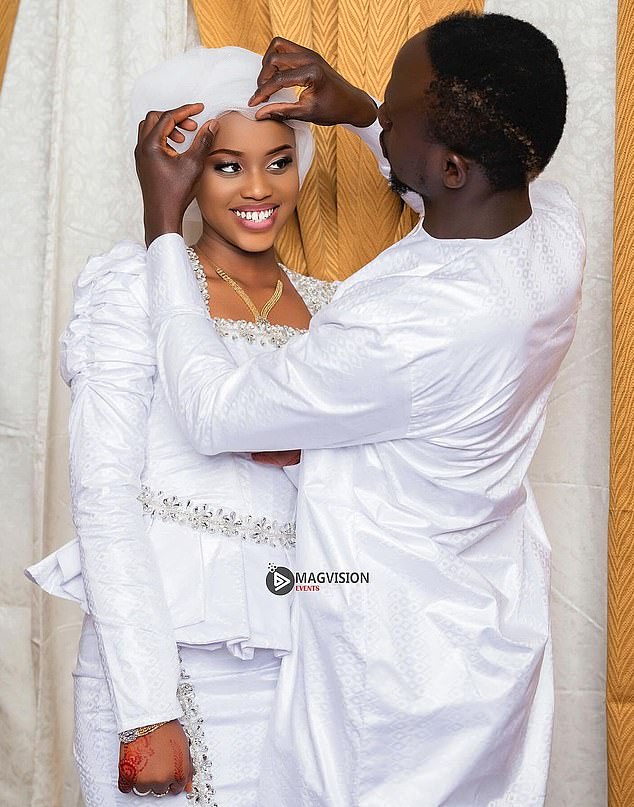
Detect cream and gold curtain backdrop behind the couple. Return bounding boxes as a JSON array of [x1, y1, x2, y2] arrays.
[[0, 0, 616, 807]]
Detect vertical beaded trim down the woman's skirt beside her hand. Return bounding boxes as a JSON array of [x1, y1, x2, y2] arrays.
[[176, 653, 218, 807]]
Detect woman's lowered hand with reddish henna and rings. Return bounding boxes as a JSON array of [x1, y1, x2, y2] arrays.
[[119, 720, 194, 796]]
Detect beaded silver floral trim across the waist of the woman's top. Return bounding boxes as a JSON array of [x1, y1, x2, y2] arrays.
[[138, 485, 295, 549]]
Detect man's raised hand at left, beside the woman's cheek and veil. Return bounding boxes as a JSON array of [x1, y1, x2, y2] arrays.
[[134, 104, 218, 246]]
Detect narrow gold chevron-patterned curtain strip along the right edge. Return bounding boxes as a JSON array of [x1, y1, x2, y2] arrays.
[[607, 0, 634, 807]]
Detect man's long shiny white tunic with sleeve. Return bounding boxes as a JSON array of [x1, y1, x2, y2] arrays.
[[143, 126, 585, 807]]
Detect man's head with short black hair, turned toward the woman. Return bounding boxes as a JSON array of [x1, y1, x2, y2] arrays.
[[379, 13, 566, 198]]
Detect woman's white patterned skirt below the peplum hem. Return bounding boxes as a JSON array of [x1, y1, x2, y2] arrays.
[[73, 618, 280, 807]]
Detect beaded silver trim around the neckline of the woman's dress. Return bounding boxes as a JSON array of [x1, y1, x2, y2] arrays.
[[187, 247, 337, 347]]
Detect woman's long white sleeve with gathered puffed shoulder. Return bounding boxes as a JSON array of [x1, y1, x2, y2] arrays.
[[61, 242, 181, 731]]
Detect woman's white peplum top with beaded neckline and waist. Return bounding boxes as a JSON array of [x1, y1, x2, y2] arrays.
[[27, 241, 334, 731]]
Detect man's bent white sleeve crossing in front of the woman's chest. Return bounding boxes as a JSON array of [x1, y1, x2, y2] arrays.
[[148, 234, 411, 454]]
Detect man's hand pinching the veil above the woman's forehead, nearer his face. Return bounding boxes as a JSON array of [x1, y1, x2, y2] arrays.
[[249, 36, 377, 127]]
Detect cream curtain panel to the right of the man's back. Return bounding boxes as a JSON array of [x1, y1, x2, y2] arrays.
[[486, 0, 612, 807]]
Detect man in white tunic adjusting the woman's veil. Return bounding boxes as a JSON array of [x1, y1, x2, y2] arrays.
[[137, 14, 584, 807]]
